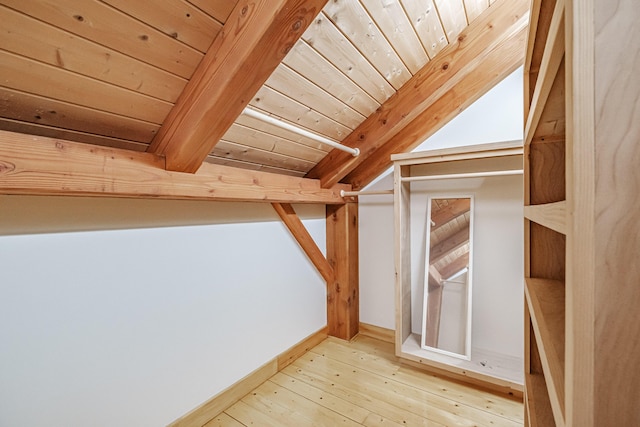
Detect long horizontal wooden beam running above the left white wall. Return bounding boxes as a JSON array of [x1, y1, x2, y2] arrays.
[[0, 131, 351, 204]]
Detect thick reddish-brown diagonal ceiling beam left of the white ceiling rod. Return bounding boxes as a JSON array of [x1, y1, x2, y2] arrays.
[[149, 0, 327, 173]]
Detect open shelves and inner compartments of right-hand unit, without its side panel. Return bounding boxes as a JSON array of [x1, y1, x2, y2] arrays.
[[524, 0, 567, 426]]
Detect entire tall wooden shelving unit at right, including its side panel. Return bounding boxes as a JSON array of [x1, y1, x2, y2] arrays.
[[524, 0, 640, 427]]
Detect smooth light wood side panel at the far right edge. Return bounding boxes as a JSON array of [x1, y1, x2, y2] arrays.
[[592, 0, 640, 425]]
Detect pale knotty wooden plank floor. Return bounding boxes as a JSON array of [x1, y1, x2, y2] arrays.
[[206, 335, 523, 427]]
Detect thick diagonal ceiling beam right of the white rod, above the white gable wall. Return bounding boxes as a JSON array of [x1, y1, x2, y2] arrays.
[[307, 0, 528, 187]]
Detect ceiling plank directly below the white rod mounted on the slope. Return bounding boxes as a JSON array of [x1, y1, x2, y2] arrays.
[[222, 123, 327, 164]]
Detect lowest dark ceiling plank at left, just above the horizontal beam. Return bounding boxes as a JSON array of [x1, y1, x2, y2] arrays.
[[0, 118, 149, 152]]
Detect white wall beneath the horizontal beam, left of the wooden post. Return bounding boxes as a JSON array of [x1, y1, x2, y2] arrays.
[[0, 196, 326, 426]]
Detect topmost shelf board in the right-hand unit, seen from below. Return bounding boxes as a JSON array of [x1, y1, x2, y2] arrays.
[[524, 0, 564, 145]]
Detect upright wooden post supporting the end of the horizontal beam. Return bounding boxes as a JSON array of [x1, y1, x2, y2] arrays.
[[327, 203, 360, 340]]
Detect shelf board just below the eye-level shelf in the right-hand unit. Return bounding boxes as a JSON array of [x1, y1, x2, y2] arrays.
[[525, 278, 565, 426]]
